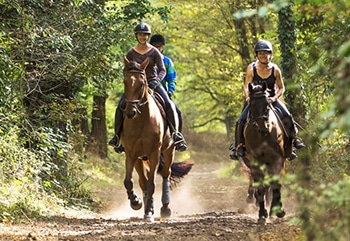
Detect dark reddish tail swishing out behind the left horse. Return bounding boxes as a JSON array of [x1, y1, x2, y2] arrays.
[[157, 156, 194, 186]]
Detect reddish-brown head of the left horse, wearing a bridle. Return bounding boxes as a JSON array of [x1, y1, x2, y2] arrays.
[[124, 57, 149, 119]]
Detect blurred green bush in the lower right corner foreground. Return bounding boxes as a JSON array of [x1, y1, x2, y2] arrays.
[[294, 134, 350, 241]]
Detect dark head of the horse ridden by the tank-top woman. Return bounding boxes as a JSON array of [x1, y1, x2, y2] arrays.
[[248, 82, 270, 135]]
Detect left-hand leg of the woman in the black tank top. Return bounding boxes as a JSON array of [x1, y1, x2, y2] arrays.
[[230, 104, 248, 160]]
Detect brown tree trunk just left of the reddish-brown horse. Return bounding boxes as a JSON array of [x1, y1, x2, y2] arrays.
[[87, 95, 107, 158]]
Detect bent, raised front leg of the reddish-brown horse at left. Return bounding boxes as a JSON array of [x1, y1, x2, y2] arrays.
[[124, 156, 142, 210]]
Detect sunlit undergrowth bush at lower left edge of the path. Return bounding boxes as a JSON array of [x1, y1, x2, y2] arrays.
[[0, 123, 90, 222]]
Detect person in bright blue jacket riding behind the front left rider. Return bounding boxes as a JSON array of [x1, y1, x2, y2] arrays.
[[150, 34, 182, 132]]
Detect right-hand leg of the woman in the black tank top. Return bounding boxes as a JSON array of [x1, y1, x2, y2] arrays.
[[273, 100, 305, 149]]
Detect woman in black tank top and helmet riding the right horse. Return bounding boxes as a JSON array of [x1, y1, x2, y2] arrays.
[[230, 40, 305, 160]]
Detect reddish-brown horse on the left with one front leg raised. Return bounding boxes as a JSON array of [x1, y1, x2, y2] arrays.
[[121, 57, 191, 222]]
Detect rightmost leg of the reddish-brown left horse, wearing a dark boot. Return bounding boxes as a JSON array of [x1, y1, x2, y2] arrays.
[[160, 151, 174, 218]]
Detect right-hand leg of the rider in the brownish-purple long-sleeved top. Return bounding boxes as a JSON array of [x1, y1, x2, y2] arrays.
[[148, 80, 187, 151]]
